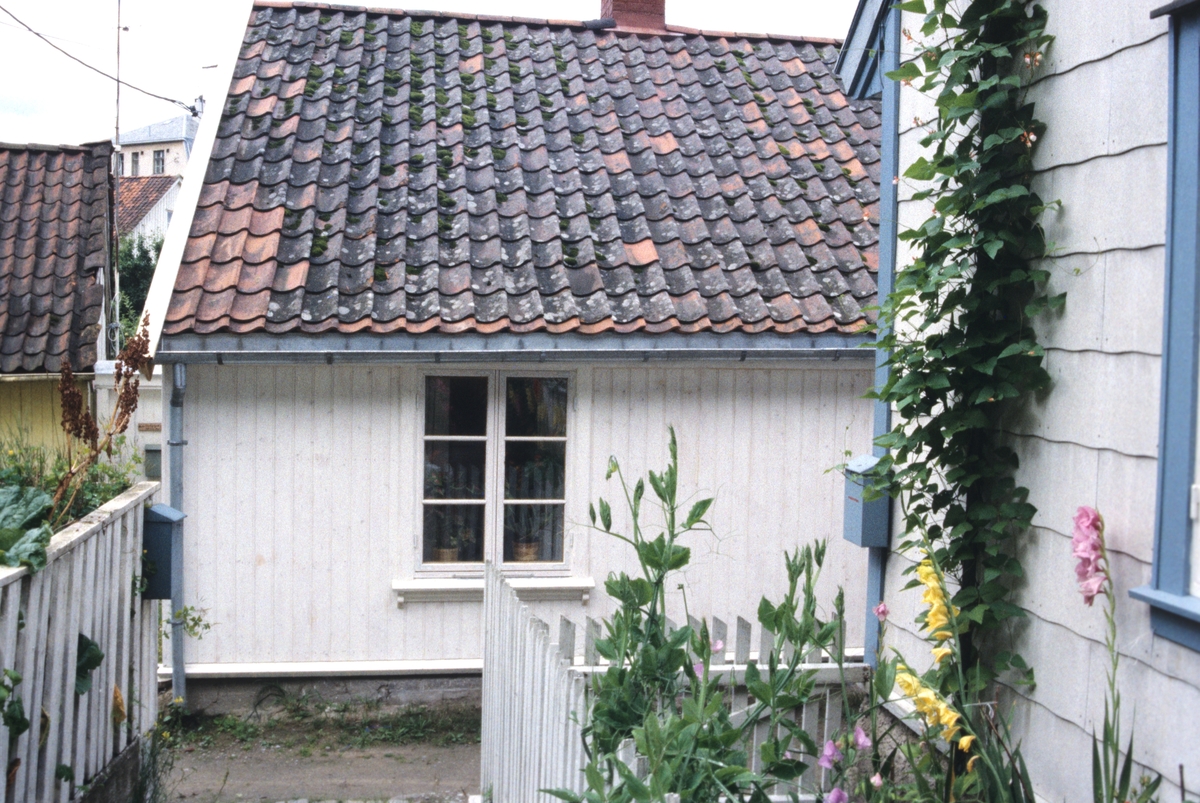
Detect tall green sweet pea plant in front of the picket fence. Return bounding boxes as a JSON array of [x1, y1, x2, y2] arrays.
[[547, 430, 845, 803]]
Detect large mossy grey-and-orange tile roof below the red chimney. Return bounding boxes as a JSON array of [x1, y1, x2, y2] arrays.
[[163, 2, 881, 335]]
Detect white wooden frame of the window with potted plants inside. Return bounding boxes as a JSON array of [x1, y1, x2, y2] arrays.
[[413, 365, 578, 579]]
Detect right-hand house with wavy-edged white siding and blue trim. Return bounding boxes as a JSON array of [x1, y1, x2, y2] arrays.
[[840, 0, 1200, 801]]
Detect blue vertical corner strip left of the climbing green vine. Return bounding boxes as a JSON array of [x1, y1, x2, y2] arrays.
[[864, 8, 901, 666]]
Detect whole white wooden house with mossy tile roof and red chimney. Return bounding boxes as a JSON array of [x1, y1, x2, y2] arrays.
[[148, 1, 880, 691]]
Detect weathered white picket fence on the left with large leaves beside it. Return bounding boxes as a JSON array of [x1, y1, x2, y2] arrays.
[[0, 483, 158, 803]]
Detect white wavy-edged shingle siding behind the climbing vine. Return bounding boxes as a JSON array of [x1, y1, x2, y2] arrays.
[[886, 0, 1200, 801]]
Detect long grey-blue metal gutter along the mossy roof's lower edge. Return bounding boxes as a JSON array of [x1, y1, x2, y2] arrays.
[[157, 331, 874, 365]]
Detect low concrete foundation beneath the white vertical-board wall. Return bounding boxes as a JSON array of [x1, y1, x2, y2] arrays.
[[187, 675, 482, 715]]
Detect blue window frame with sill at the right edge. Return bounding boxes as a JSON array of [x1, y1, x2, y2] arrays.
[[1130, 0, 1200, 651]]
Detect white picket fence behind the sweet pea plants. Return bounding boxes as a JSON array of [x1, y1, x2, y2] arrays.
[[481, 564, 868, 803]]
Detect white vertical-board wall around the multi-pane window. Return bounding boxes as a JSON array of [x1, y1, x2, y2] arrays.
[[175, 362, 871, 664]]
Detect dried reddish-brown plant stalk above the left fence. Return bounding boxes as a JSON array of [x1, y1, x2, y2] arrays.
[[50, 316, 150, 529]]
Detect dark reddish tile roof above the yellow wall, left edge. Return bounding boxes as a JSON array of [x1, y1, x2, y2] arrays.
[[0, 142, 113, 373]]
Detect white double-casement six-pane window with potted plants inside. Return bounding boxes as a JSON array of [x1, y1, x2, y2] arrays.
[[421, 376, 568, 564]]
